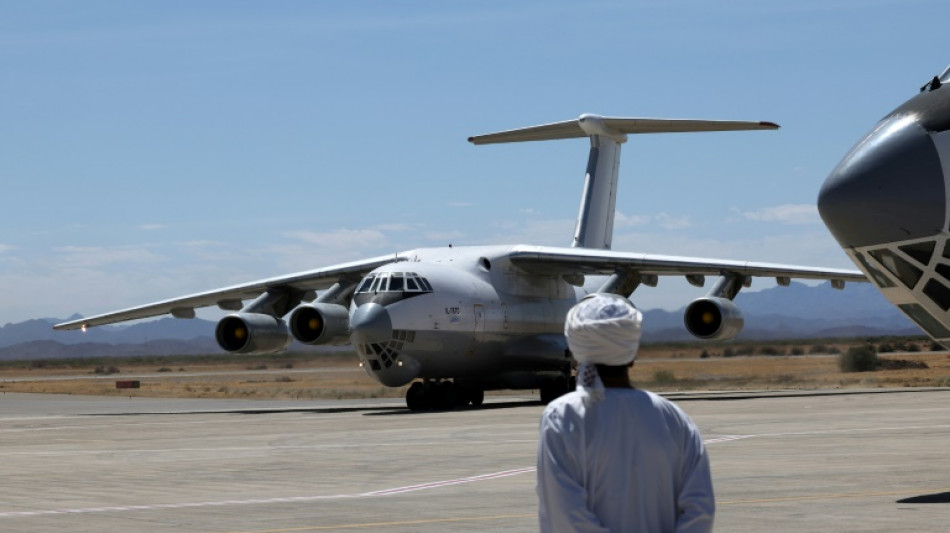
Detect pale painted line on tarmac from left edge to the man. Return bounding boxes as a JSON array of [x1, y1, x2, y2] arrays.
[[0, 467, 535, 518]]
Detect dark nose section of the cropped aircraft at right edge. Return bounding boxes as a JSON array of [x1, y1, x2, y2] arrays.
[[818, 67, 950, 348]]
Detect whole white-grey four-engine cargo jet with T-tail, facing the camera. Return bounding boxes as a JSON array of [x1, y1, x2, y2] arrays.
[[54, 115, 865, 410]]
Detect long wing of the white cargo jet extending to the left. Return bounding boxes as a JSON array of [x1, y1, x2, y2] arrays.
[[53, 254, 405, 330]]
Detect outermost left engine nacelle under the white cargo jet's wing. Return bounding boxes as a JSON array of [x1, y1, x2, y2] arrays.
[[214, 313, 291, 355]]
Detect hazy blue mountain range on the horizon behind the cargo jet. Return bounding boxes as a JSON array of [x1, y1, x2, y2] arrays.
[[0, 283, 923, 360]]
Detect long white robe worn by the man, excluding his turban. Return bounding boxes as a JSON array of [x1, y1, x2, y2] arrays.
[[537, 388, 716, 533]]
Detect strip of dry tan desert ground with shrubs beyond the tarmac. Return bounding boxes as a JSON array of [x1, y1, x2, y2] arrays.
[[0, 339, 950, 400]]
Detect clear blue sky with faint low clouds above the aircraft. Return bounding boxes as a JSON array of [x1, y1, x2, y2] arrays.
[[0, 0, 950, 323]]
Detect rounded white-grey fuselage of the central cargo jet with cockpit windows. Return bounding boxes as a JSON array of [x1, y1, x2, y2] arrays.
[[350, 246, 587, 389]]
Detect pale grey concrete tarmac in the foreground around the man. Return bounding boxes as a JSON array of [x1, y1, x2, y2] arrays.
[[0, 389, 950, 533]]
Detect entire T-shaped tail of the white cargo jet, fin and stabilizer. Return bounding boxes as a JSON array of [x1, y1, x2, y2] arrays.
[[468, 114, 779, 250]]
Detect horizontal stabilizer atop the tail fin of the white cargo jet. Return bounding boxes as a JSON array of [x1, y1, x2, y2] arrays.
[[468, 115, 779, 144]]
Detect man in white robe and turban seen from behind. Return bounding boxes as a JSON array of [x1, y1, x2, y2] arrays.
[[537, 294, 715, 533]]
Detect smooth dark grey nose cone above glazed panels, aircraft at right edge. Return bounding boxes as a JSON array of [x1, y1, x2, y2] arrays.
[[818, 115, 946, 248]]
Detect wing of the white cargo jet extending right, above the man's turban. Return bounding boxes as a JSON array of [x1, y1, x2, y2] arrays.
[[511, 246, 868, 287]]
